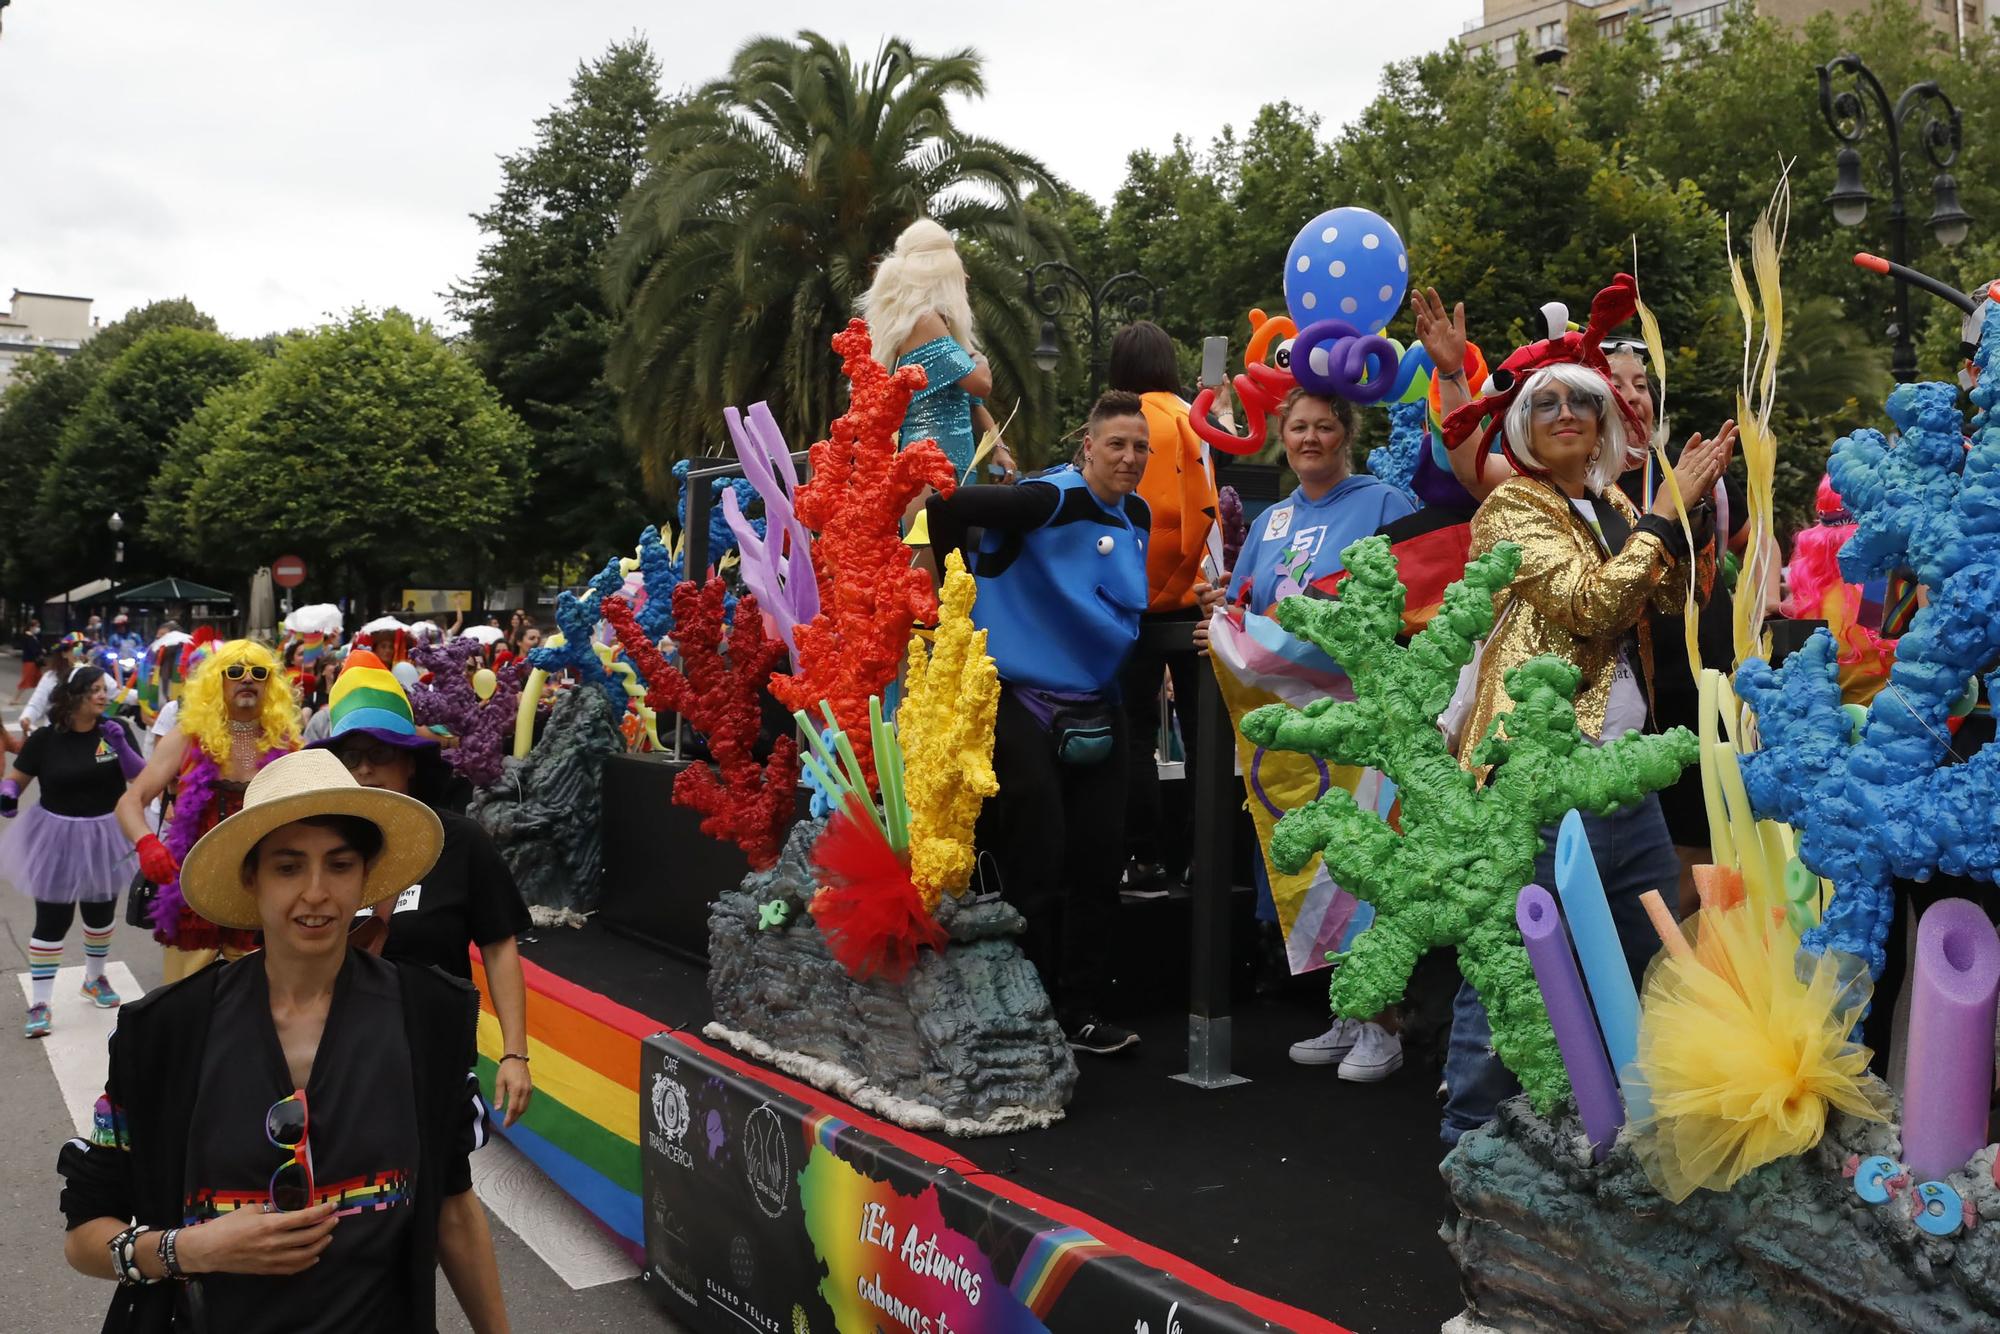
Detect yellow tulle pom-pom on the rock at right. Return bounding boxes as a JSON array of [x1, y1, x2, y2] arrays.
[[1630, 908, 1890, 1202]]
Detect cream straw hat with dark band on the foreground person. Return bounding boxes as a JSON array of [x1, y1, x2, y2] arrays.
[[180, 750, 444, 930]]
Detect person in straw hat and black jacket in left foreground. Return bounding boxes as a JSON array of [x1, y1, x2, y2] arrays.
[[58, 750, 508, 1334]]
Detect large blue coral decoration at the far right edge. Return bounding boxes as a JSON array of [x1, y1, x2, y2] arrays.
[[1736, 320, 2000, 976]]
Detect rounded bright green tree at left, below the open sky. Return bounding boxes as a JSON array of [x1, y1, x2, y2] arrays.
[[171, 310, 530, 598]]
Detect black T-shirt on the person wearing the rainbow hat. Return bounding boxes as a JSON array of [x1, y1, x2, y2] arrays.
[[382, 810, 532, 982]]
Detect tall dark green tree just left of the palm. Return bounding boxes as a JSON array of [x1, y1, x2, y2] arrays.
[[452, 38, 666, 574]]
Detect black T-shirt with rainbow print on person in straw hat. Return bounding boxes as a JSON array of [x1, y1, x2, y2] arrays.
[[184, 952, 478, 1334]]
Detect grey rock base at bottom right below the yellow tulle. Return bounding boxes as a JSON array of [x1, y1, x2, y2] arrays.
[[1442, 1098, 2000, 1334]]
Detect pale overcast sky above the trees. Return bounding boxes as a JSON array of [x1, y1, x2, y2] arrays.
[[0, 0, 1480, 336]]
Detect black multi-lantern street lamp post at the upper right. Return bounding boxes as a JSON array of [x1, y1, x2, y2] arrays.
[[1820, 56, 1972, 384]]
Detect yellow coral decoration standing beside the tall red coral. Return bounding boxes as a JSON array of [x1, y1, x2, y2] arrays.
[[896, 552, 1000, 912]]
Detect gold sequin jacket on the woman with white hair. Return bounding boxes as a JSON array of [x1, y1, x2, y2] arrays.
[[1458, 478, 1714, 764]]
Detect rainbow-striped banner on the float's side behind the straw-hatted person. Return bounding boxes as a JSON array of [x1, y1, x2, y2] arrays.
[[472, 950, 644, 1266]]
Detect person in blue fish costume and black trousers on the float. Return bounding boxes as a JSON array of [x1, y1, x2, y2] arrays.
[[928, 390, 1150, 1054]]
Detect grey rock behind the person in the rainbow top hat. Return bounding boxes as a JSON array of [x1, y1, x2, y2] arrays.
[[468, 690, 624, 926]]
